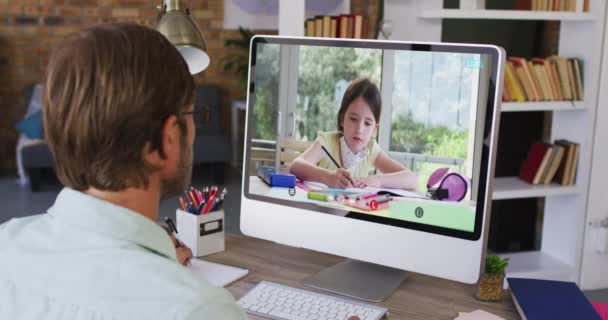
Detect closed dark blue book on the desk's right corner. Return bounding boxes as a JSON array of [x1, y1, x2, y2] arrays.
[[507, 278, 601, 320]]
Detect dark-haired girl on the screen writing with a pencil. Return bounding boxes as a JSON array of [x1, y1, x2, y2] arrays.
[[289, 78, 417, 190]]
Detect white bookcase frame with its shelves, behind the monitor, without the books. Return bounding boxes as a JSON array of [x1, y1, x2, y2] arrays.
[[385, 0, 608, 288]]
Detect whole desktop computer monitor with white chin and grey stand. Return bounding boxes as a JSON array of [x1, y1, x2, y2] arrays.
[[241, 36, 505, 301]]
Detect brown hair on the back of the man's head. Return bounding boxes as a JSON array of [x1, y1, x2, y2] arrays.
[[42, 24, 194, 191]]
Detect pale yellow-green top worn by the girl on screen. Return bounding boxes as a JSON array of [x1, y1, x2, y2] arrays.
[[317, 131, 382, 178]]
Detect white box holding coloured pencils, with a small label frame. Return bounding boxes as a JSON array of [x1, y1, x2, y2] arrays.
[[175, 209, 225, 257]]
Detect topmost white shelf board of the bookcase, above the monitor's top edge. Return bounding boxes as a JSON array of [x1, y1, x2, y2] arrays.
[[419, 9, 597, 21]]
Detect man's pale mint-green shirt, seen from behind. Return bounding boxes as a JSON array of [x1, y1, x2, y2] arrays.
[[0, 188, 246, 320]]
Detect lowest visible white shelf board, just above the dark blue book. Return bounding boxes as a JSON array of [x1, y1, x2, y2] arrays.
[[499, 251, 575, 285]]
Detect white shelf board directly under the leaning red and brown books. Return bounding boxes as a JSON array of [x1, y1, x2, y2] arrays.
[[492, 177, 581, 200]]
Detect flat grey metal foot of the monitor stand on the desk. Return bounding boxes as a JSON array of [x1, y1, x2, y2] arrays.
[[302, 259, 407, 302]]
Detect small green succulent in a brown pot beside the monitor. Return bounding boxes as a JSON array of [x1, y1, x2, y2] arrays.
[[476, 254, 509, 301]]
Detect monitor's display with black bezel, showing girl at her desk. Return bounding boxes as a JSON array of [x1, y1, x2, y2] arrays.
[[244, 37, 499, 240]]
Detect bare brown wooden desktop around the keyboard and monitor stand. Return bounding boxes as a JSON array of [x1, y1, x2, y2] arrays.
[[205, 235, 519, 320]]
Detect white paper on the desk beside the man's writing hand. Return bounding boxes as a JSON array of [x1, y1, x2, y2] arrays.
[[188, 258, 249, 288]]
